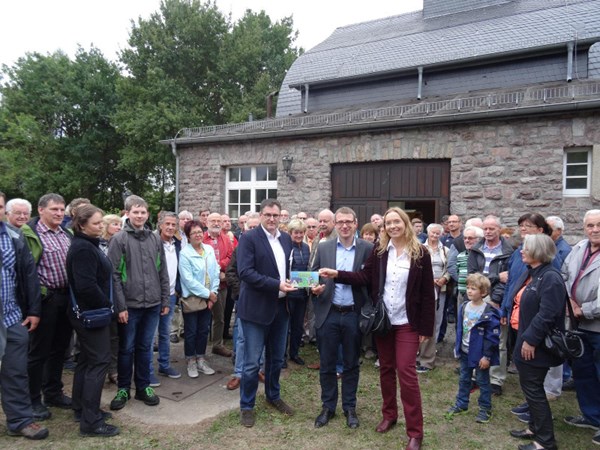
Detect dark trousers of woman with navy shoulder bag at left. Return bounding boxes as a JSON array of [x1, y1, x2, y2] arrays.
[[69, 313, 111, 431]]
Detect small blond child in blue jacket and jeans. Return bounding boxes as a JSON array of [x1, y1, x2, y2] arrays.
[[447, 273, 500, 423]]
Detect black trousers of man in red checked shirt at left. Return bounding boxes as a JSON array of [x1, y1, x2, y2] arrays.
[[27, 292, 73, 405]]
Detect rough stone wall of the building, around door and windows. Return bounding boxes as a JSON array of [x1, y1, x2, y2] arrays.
[[179, 113, 600, 242]]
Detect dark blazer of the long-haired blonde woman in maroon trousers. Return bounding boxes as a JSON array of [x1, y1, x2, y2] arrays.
[[337, 245, 435, 337]]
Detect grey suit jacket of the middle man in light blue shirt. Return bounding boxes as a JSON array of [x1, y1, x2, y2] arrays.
[[311, 239, 373, 328]]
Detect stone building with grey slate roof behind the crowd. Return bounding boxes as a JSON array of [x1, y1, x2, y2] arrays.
[[165, 0, 600, 239]]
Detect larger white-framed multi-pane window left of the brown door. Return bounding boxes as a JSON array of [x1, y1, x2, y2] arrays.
[[225, 165, 277, 220]]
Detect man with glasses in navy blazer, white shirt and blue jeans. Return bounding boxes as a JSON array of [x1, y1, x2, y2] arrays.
[[237, 199, 295, 427]]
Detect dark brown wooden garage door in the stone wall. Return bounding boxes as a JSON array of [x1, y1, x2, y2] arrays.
[[331, 160, 450, 225]]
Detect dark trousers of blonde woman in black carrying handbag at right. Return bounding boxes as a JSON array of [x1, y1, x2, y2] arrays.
[[515, 361, 557, 449]]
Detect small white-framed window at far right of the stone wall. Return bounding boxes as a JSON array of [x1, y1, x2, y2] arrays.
[[563, 147, 592, 197]]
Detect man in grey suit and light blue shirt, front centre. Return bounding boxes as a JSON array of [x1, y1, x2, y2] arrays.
[[311, 207, 373, 428]]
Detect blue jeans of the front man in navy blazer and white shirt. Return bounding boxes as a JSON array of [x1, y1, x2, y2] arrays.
[[239, 300, 289, 410]]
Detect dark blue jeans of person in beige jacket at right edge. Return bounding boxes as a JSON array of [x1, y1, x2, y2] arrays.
[[573, 330, 600, 426]]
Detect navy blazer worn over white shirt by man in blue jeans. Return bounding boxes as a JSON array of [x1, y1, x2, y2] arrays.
[[237, 226, 292, 325]]
